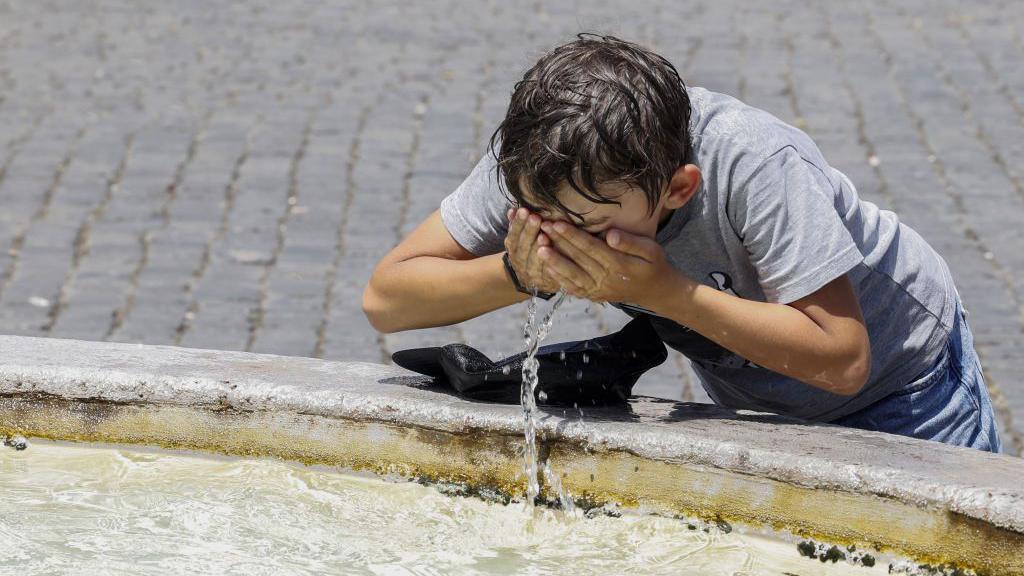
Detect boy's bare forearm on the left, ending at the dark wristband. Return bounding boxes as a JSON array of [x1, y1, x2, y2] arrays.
[[362, 253, 528, 332]]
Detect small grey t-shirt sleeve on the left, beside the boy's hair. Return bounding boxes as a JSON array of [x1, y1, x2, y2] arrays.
[[440, 150, 511, 256]]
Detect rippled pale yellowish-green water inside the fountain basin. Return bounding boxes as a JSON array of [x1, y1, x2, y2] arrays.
[[0, 441, 885, 576]]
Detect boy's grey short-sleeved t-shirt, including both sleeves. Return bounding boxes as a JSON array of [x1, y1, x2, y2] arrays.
[[440, 87, 958, 421]]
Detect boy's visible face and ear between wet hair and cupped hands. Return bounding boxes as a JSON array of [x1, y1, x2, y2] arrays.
[[520, 164, 700, 240]]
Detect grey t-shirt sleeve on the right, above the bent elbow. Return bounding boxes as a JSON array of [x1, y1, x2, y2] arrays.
[[728, 147, 863, 303]]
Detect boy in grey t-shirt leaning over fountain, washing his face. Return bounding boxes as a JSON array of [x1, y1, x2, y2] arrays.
[[364, 34, 1000, 452]]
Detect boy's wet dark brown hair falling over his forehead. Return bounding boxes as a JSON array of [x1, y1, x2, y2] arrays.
[[489, 32, 690, 219]]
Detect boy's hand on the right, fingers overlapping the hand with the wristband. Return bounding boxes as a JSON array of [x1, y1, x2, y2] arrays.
[[536, 217, 675, 307]]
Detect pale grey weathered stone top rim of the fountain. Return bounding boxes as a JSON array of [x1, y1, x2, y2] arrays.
[[0, 336, 1024, 533]]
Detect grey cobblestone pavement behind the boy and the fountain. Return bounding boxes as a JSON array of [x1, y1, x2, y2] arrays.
[[0, 0, 1024, 452]]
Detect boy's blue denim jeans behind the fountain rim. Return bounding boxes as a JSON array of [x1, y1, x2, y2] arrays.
[[833, 297, 1002, 452]]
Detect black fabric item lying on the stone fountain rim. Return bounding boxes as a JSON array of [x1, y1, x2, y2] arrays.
[[391, 317, 668, 406]]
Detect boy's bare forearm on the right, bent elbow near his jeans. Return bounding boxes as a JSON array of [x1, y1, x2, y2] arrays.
[[637, 273, 863, 394]]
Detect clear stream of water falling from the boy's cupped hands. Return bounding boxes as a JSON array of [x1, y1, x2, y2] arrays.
[[520, 290, 571, 506]]
